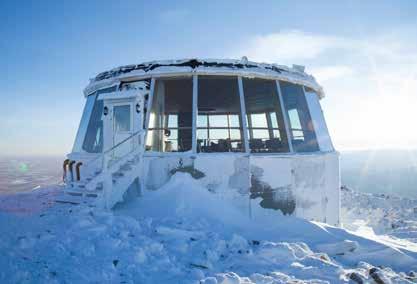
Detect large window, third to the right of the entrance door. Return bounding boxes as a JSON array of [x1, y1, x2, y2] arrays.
[[243, 78, 288, 153]]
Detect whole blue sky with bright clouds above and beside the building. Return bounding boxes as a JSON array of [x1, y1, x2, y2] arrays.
[[0, 0, 417, 155]]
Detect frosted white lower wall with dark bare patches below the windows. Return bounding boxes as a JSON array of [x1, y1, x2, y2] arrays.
[[143, 152, 340, 225]]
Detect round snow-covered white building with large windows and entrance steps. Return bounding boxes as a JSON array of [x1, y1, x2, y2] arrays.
[[64, 58, 340, 225]]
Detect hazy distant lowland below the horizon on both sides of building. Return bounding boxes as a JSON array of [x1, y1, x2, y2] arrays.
[[0, 150, 417, 198]]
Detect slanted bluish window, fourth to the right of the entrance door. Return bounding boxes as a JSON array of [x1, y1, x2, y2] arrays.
[[280, 81, 319, 152]]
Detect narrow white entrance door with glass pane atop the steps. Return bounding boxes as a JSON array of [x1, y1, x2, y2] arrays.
[[112, 103, 133, 158]]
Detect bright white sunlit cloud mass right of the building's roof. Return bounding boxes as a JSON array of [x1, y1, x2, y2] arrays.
[[239, 30, 417, 149]]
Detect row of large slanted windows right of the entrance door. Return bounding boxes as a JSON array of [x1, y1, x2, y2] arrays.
[[146, 76, 332, 153]]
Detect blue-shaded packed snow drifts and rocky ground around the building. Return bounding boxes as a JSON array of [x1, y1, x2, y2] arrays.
[[0, 173, 417, 284]]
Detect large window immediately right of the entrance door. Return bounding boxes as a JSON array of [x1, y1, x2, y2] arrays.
[[146, 77, 193, 152]]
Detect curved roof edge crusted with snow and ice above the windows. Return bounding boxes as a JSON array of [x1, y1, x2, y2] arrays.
[[84, 57, 324, 98]]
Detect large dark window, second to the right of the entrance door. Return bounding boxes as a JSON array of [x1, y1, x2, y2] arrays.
[[197, 76, 244, 152]]
